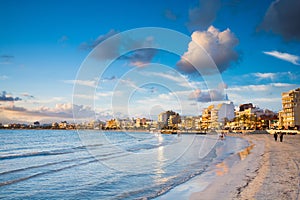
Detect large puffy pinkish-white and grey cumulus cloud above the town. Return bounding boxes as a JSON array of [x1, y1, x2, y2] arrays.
[[177, 26, 239, 74]]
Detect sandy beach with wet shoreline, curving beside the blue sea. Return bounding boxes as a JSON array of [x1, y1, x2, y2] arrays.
[[160, 134, 300, 200]]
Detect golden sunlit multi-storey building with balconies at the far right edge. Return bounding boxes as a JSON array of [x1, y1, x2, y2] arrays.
[[279, 88, 300, 129]]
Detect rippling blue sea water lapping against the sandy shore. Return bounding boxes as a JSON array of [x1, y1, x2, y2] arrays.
[[0, 130, 248, 199]]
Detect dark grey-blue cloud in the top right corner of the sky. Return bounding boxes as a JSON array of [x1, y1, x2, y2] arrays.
[[258, 0, 300, 40]]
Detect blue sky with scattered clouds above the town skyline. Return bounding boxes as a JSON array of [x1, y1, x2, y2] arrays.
[[0, 0, 300, 124]]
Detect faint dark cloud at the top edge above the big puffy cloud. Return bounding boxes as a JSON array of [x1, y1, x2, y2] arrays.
[[187, 0, 221, 30]]
